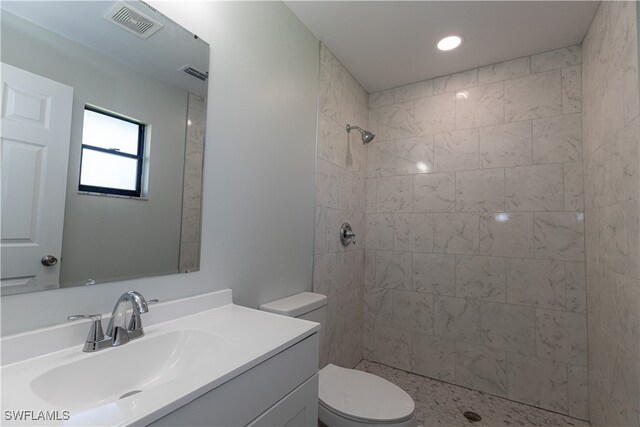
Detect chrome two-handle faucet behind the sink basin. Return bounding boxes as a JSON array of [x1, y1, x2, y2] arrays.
[[67, 291, 158, 352]]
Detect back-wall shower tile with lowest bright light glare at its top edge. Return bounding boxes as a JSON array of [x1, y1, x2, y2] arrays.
[[480, 212, 533, 258]]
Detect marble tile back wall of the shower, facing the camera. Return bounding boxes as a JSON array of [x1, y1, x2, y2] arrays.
[[364, 46, 588, 419]]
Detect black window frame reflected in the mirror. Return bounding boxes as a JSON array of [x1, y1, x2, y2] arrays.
[[78, 105, 146, 198]]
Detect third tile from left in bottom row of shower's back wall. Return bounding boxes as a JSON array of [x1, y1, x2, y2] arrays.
[[456, 342, 507, 396]]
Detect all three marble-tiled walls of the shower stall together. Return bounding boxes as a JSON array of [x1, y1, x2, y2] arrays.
[[314, 2, 640, 425]]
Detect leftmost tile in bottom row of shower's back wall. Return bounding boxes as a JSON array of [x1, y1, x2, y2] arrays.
[[373, 326, 411, 371]]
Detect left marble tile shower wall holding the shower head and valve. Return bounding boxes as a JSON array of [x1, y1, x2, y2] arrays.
[[313, 44, 368, 368]]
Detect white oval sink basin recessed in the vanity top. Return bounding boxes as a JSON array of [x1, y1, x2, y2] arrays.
[[31, 329, 229, 409]]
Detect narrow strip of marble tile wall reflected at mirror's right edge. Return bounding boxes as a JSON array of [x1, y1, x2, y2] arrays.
[[180, 93, 206, 273]]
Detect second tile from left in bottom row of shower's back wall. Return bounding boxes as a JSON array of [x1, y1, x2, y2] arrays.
[[411, 333, 456, 382]]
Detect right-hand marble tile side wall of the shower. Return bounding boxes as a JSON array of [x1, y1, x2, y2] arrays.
[[584, 2, 640, 426]]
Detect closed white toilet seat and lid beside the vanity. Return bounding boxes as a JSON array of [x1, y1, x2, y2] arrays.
[[318, 364, 415, 424]]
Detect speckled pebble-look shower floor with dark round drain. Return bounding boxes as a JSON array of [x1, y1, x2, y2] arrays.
[[356, 360, 589, 427]]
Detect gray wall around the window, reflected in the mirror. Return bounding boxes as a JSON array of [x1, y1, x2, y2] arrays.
[[2, 12, 188, 287]]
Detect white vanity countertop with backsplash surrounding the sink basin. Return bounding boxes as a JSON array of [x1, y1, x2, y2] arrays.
[[0, 291, 320, 426]]
